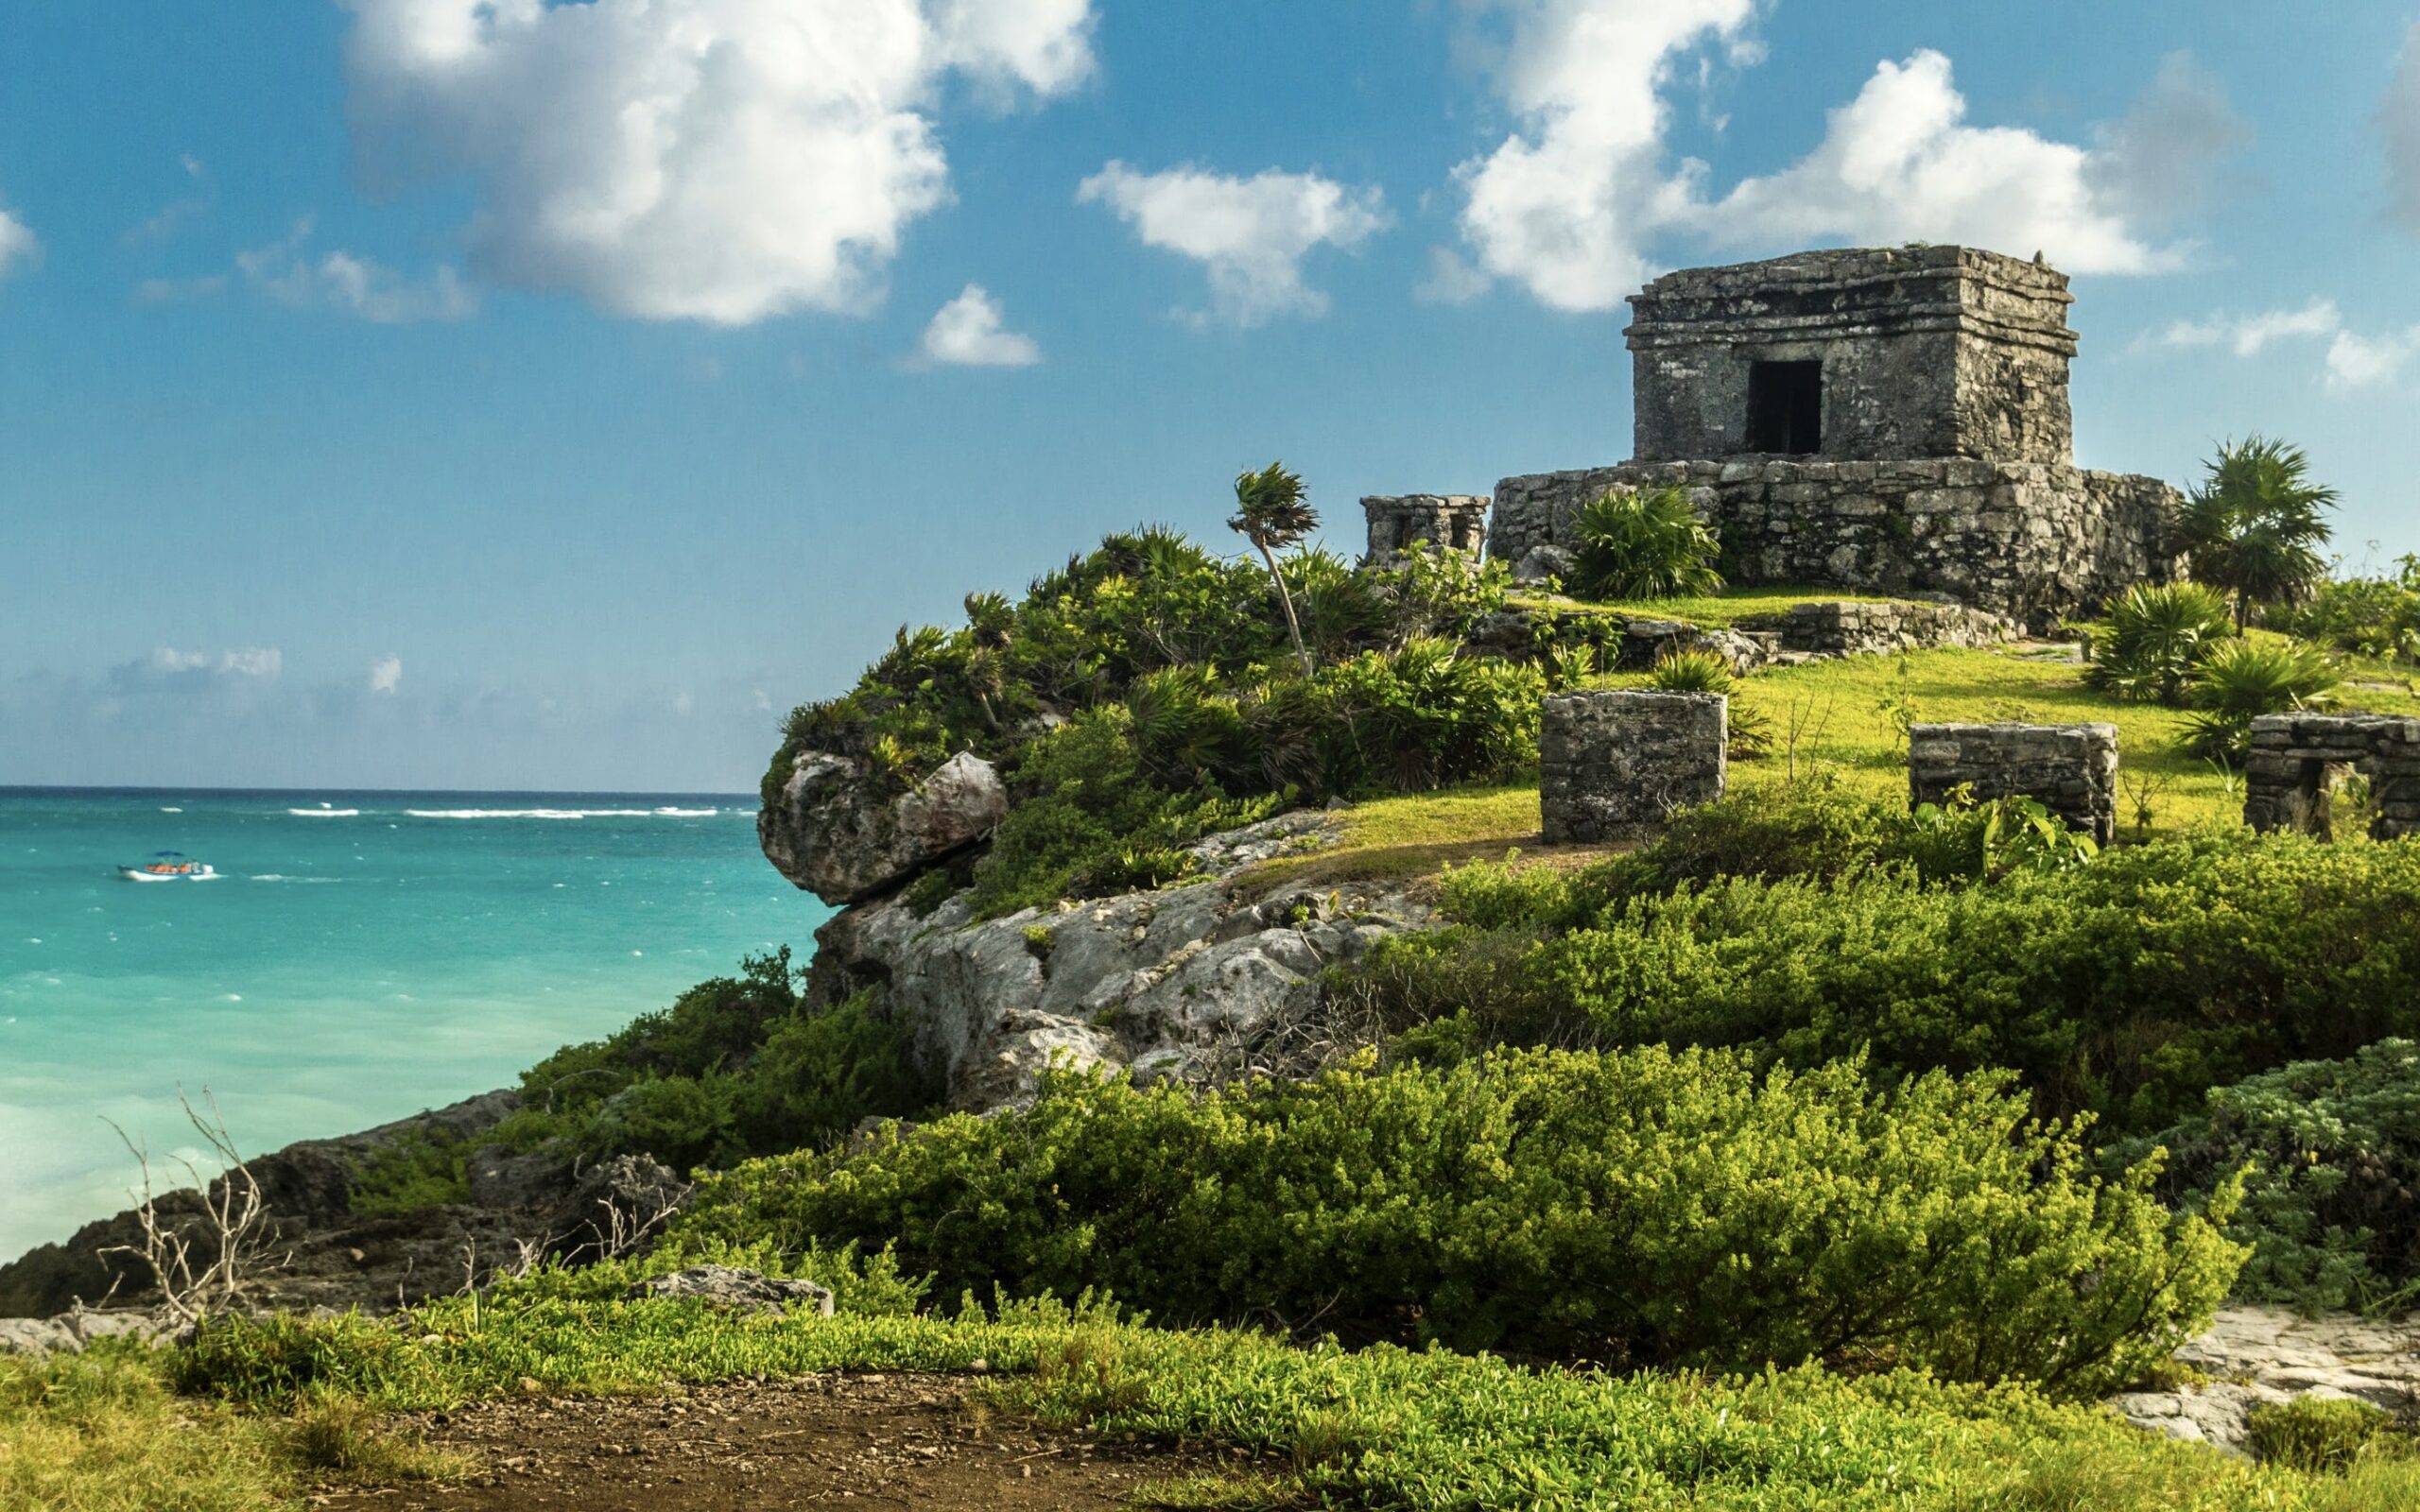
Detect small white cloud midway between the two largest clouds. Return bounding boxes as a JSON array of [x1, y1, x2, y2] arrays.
[[1075, 163, 1389, 327]]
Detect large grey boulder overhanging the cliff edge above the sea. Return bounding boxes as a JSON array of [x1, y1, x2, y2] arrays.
[[757, 750, 1010, 902]]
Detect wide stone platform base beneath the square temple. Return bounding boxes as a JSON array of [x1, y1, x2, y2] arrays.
[[1488, 457, 2183, 627]]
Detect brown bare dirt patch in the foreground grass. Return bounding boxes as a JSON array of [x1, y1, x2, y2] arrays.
[[312, 1374, 1215, 1512]]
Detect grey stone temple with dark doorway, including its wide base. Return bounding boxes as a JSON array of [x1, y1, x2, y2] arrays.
[[1488, 247, 2181, 624]]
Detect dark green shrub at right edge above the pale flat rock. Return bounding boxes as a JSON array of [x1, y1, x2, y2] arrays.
[[2125, 1040, 2420, 1312]]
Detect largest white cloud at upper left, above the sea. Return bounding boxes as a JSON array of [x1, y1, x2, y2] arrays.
[[346, 0, 1092, 324]]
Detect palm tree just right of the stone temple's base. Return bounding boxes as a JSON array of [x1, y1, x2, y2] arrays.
[[2178, 436, 2335, 629]]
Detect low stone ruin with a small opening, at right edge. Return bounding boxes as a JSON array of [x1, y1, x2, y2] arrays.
[[2243, 713, 2420, 839]]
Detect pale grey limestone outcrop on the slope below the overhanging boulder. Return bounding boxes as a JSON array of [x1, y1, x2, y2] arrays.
[[816, 813, 1430, 1110]]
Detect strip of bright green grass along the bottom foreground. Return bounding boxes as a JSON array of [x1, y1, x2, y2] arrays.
[[23, 1275, 2420, 1512]]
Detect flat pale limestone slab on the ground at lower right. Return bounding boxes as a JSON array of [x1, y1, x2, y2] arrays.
[[2110, 1306, 2420, 1449]]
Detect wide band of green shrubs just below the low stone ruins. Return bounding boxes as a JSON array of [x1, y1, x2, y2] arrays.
[[1345, 833, 2420, 1132]]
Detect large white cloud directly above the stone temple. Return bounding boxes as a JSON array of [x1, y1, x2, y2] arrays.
[[1426, 0, 2243, 310]]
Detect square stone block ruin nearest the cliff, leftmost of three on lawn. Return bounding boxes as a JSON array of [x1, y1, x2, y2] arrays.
[[1537, 690, 1730, 844]]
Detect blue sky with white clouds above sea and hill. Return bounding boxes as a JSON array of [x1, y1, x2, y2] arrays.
[[0, 0, 2420, 789]]
